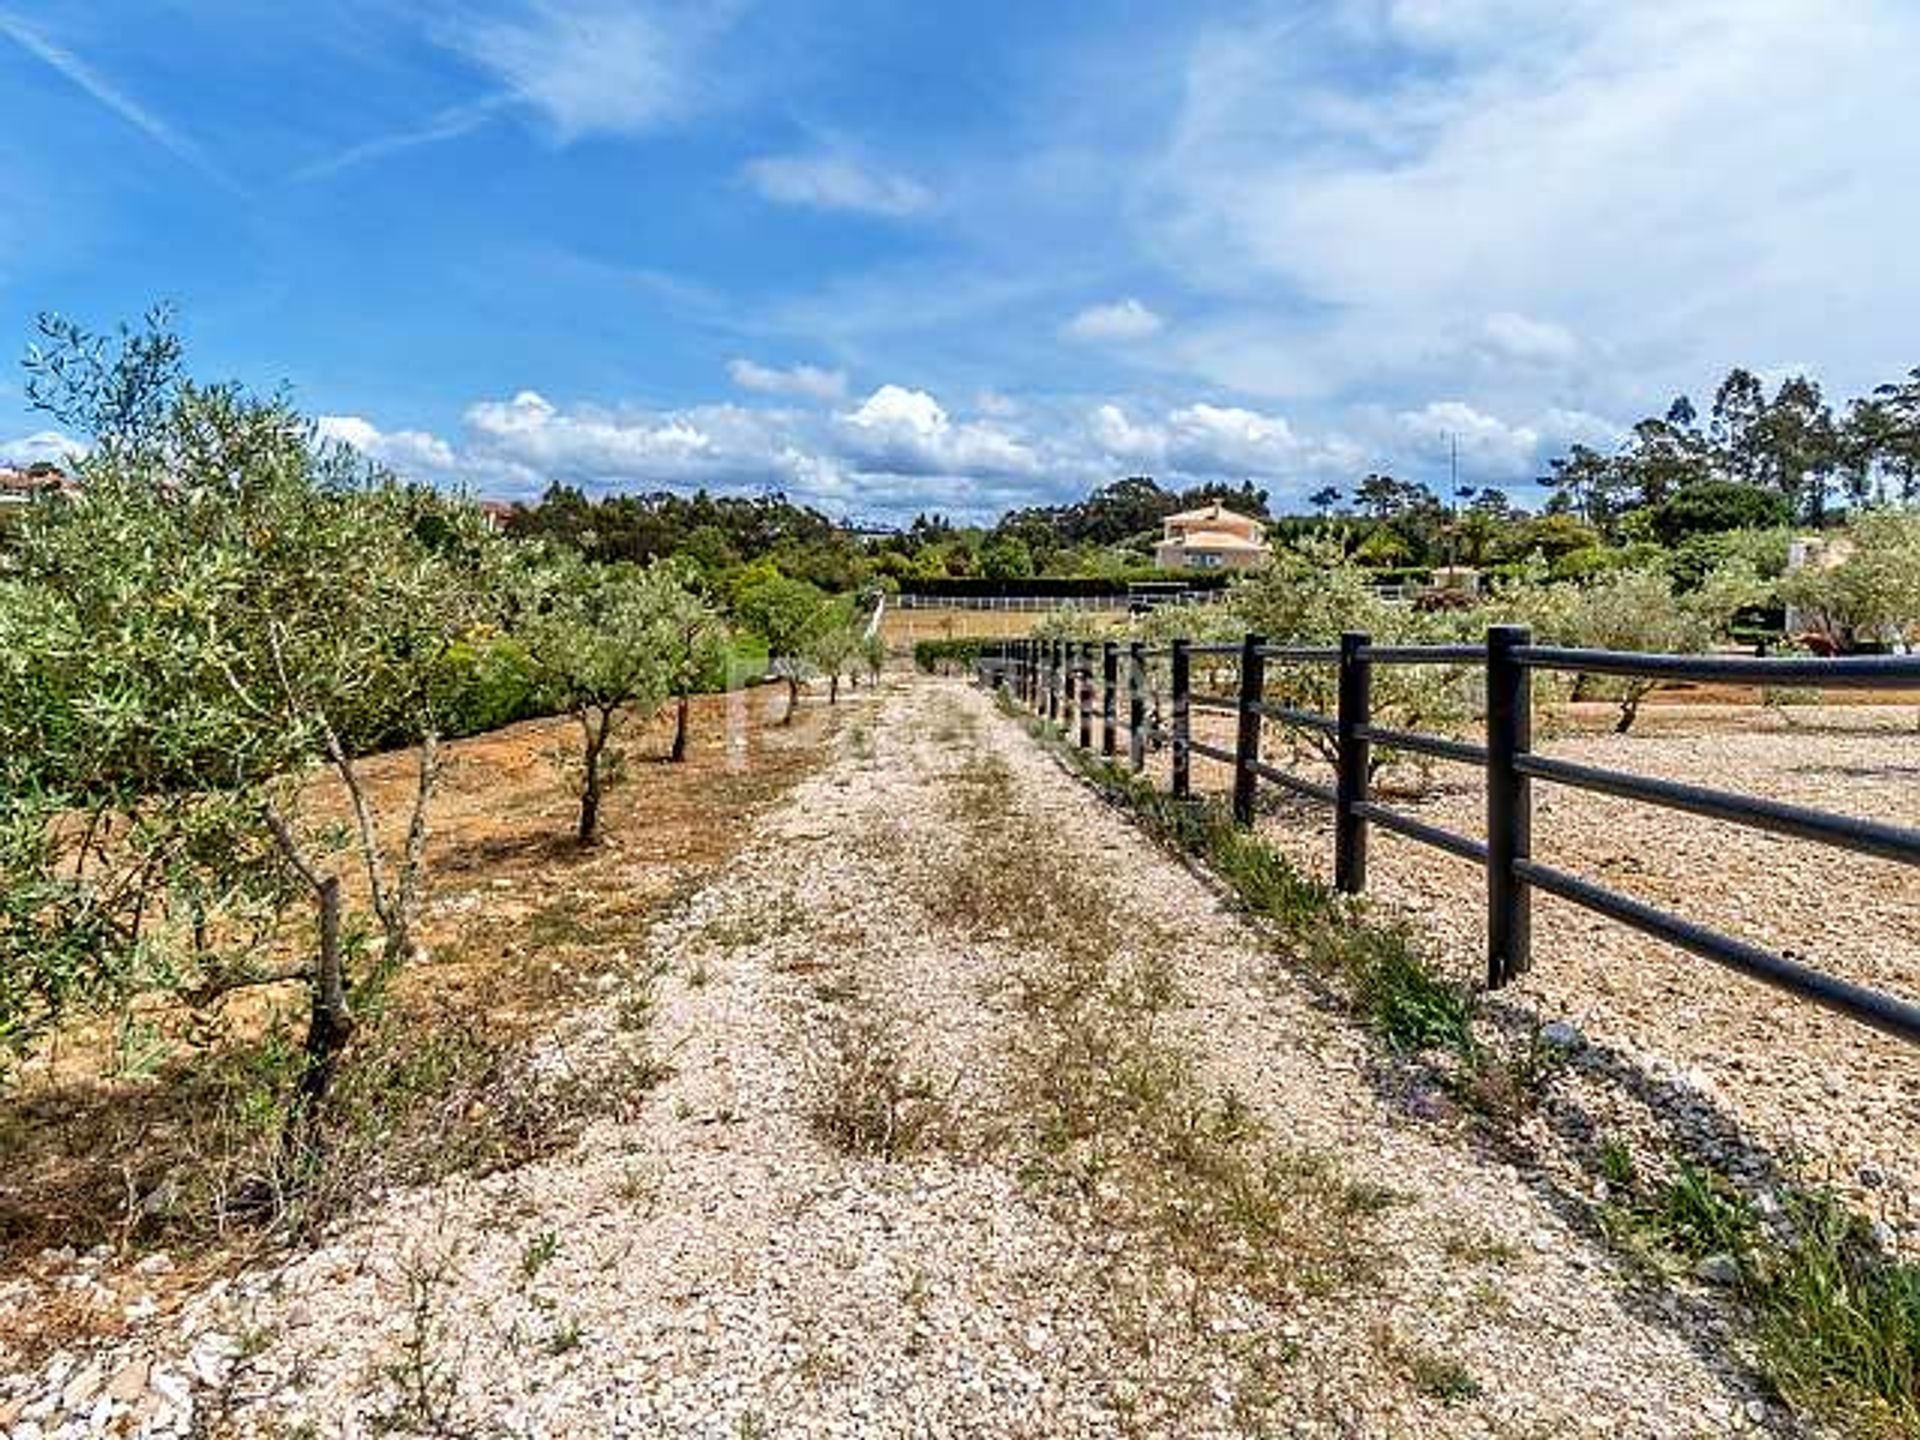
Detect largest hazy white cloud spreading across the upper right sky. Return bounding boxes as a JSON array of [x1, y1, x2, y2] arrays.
[[1135, 0, 1920, 413]]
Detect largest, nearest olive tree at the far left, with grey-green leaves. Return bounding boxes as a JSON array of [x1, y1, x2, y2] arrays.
[[0, 324, 492, 1114]]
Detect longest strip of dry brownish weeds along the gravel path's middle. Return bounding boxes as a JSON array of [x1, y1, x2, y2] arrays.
[[922, 756, 1392, 1344]]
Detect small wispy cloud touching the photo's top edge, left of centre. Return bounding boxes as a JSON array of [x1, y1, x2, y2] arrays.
[[444, 0, 733, 142]]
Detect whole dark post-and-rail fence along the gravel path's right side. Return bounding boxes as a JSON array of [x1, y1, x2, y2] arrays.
[[979, 626, 1920, 1043]]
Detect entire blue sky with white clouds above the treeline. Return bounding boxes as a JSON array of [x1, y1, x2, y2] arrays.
[[0, 0, 1920, 516]]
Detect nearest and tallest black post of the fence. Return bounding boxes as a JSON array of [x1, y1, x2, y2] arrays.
[[1486, 626, 1534, 989]]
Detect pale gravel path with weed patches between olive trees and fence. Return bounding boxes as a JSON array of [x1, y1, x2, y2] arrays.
[[21, 682, 1782, 1436]]
